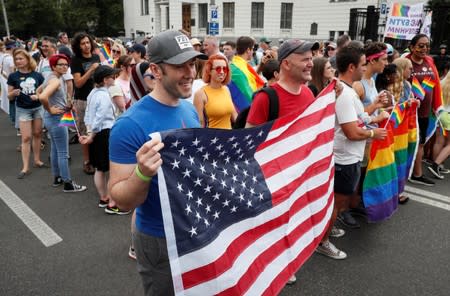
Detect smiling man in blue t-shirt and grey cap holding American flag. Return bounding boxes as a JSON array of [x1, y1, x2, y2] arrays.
[[109, 31, 207, 295]]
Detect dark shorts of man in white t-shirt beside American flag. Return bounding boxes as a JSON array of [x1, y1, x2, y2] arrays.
[[334, 162, 361, 195]]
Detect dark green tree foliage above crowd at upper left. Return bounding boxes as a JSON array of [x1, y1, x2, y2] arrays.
[[0, 0, 124, 39]]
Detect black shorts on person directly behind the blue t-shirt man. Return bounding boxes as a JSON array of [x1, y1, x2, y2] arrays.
[[89, 129, 110, 172]]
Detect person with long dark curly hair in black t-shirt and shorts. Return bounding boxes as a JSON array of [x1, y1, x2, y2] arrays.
[[70, 33, 100, 175]]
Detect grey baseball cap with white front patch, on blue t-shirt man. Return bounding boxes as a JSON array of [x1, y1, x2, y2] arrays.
[[147, 31, 208, 65]]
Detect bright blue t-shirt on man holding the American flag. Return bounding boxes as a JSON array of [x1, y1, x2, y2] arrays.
[[109, 95, 200, 237]]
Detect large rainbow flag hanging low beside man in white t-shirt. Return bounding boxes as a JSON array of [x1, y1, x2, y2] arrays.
[[363, 103, 418, 222]]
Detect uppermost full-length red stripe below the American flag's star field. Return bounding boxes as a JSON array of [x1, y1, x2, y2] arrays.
[[182, 169, 334, 289]]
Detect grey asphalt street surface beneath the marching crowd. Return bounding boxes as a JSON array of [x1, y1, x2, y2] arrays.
[[0, 111, 450, 296]]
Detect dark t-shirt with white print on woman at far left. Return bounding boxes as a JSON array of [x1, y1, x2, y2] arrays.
[[8, 71, 44, 109]]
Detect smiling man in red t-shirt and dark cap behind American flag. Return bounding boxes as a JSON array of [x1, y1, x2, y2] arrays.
[[245, 39, 319, 127]]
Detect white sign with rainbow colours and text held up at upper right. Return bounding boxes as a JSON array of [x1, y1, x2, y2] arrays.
[[384, 3, 424, 40]]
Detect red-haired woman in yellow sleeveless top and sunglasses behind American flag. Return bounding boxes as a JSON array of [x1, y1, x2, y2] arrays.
[[194, 55, 237, 129]]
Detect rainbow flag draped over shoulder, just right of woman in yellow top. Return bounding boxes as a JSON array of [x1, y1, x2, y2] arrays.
[[228, 56, 264, 112]]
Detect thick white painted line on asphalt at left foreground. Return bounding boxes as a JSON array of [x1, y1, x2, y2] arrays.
[[0, 180, 62, 247]]
